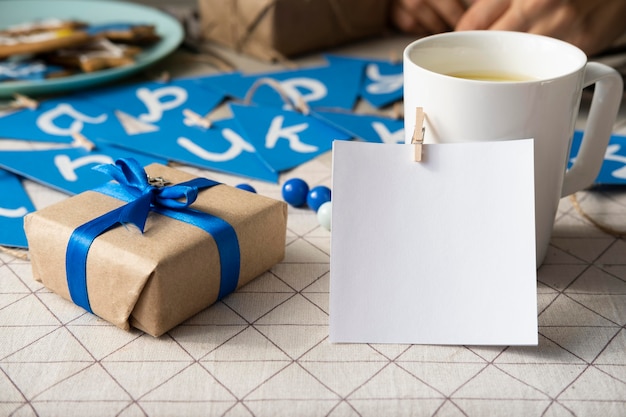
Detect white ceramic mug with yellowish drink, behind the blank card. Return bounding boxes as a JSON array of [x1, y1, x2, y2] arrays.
[[404, 31, 623, 265]]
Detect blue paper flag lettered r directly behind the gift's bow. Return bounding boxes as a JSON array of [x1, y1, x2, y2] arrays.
[[0, 146, 167, 194]]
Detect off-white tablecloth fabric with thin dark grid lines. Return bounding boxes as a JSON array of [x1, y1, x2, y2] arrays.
[[0, 150, 626, 417]]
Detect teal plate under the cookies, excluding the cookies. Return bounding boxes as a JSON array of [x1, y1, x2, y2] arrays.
[[0, 0, 184, 97]]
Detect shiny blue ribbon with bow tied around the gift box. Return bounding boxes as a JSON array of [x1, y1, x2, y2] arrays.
[[65, 158, 240, 313]]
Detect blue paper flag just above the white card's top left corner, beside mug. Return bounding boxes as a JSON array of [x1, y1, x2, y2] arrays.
[[312, 111, 404, 143]]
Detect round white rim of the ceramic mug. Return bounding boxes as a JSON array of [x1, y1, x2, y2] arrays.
[[403, 30, 588, 84]]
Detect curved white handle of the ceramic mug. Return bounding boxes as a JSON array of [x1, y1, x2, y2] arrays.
[[561, 62, 623, 197]]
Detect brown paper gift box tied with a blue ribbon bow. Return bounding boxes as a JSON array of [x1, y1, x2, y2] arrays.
[[24, 160, 287, 336]]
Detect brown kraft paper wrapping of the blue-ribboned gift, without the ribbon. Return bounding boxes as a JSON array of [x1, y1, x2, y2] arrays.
[[24, 164, 287, 336]]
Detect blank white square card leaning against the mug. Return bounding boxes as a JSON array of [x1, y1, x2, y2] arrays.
[[330, 139, 538, 345]]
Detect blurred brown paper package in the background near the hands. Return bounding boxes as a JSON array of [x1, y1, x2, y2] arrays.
[[199, 0, 389, 61]]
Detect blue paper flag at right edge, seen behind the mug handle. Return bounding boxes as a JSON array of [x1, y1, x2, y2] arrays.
[[569, 130, 626, 185]]
